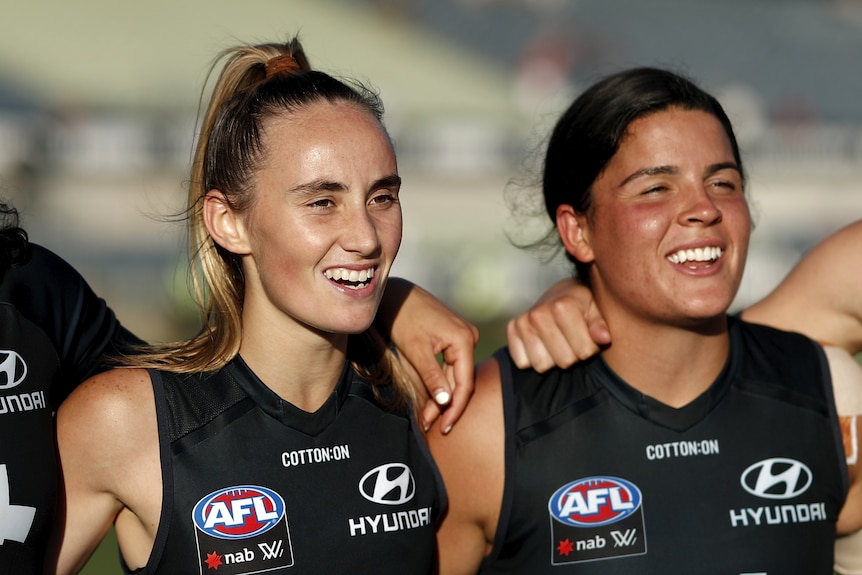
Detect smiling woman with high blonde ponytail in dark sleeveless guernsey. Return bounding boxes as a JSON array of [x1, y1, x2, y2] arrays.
[[49, 39, 445, 574]]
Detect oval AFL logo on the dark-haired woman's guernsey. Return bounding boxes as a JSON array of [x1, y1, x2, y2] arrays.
[[548, 477, 641, 527]]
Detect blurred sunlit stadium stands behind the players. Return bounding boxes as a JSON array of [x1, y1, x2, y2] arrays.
[[0, 0, 862, 575]]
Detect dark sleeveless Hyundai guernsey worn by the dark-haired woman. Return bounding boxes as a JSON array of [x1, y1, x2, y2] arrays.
[[481, 318, 847, 575]]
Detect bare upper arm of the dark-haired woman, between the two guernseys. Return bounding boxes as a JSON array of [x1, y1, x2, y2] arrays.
[[428, 359, 505, 575]]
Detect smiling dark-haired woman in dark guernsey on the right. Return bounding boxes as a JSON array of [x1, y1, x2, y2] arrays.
[[429, 68, 862, 575]]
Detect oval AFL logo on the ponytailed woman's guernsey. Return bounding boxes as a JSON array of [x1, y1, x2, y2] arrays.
[[192, 485, 285, 539]]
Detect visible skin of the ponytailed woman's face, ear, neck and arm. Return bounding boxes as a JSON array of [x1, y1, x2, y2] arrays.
[[48, 101, 408, 573]]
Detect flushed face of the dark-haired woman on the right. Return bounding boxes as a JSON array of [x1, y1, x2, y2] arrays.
[[581, 109, 751, 332]]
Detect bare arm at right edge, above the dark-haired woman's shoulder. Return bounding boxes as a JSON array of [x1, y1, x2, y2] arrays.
[[743, 220, 862, 354]]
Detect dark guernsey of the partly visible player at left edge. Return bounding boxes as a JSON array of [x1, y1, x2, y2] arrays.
[[0, 244, 138, 575]]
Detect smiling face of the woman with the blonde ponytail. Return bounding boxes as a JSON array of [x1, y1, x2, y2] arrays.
[[238, 102, 401, 342]]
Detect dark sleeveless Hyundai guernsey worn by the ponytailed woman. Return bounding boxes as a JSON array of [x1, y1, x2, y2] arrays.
[[140, 357, 445, 575]]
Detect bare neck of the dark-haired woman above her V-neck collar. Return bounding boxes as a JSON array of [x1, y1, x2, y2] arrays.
[[603, 316, 730, 407]]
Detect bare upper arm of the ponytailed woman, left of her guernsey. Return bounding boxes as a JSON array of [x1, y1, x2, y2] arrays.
[[47, 369, 162, 573]]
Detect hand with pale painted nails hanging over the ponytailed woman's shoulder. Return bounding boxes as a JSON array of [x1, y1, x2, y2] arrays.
[[376, 278, 479, 432]]
